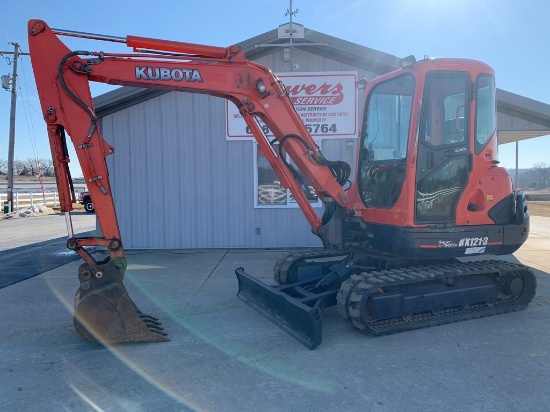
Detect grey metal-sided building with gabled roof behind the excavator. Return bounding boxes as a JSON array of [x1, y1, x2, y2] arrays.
[[94, 26, 550, 249]]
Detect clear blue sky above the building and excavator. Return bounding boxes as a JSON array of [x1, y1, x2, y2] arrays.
[[0, 0, 550, 177]]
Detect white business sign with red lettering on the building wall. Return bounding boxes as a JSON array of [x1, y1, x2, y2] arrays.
[[226, 72, 357, 140]]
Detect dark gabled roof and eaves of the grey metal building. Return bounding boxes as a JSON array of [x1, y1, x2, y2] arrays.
[[94, 26, 550, 144]]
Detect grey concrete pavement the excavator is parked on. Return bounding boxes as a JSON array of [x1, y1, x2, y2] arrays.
[[0, 216, 550, 411]]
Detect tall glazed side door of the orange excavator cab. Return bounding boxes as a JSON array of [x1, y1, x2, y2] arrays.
[[415, 71, 471, 224]]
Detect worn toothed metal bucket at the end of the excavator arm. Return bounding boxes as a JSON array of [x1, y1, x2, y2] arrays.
[[73, 258, 170, 344]]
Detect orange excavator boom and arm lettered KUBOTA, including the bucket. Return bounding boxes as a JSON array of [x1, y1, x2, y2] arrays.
[[28, 20, 350, 343]]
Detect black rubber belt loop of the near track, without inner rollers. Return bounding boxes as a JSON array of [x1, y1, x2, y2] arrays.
[[337, 260, 537, 336]]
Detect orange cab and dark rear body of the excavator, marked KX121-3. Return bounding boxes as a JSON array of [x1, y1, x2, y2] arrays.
[[350, 59, 529, 259]]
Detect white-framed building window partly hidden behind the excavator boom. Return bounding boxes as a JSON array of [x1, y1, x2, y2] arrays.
[[254, 143, 322, 208]]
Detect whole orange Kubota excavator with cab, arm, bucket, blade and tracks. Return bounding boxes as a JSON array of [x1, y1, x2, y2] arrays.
[[28, 20, 536, 348]]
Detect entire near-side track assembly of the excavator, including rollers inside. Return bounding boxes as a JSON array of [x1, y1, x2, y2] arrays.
[[336, 260, 536, 335]]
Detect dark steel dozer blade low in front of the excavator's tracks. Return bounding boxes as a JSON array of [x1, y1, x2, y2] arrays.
[[235, 268, 336, 349]]
